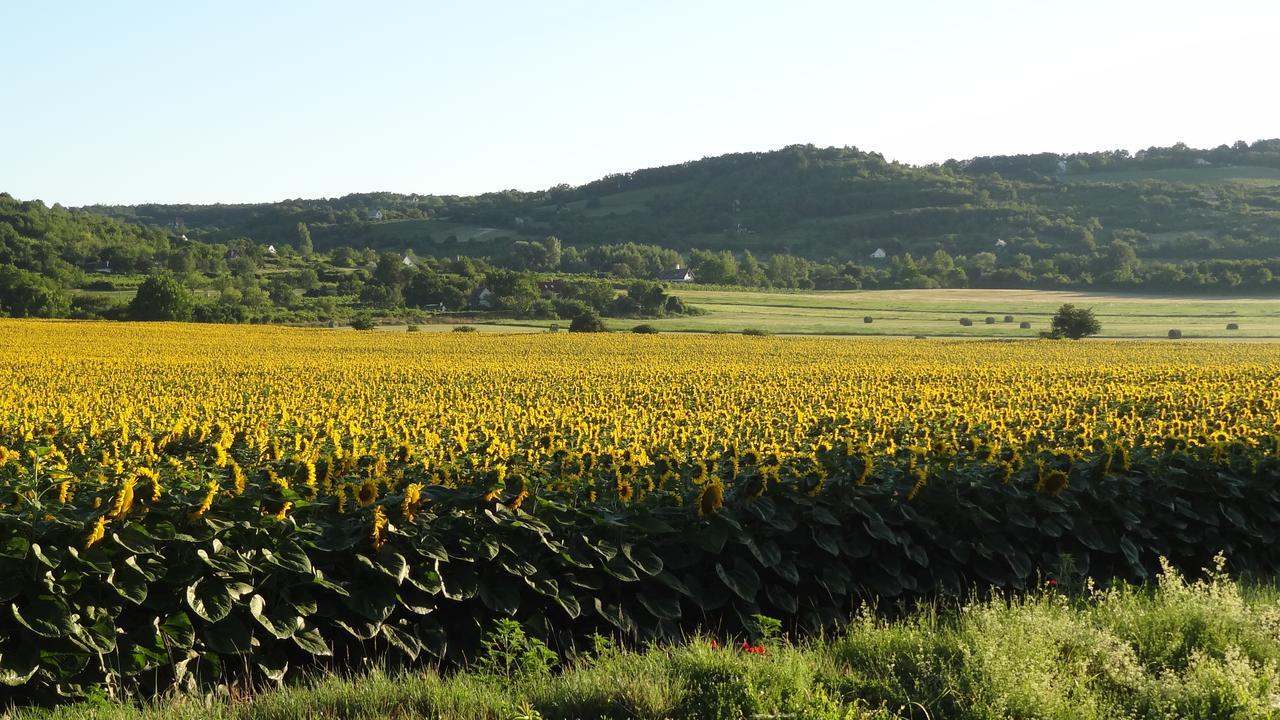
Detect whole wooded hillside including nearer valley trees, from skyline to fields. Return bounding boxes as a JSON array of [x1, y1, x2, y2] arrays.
[[0, 140, 1280, 322]]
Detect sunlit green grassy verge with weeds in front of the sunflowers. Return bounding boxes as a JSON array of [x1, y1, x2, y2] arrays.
[[20, 561, 1280, 720]]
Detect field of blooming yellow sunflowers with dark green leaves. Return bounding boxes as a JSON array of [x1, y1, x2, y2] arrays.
[[0, 322, 1280, 702]]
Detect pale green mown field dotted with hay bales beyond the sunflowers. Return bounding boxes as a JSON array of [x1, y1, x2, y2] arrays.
[[491, 287, 1280, 340]]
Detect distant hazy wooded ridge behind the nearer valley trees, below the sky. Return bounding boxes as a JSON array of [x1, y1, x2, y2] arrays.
[[77, 140, 1280, 261]]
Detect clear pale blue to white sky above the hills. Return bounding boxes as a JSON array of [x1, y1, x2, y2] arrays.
[[0, 0, 1280, 205]]
